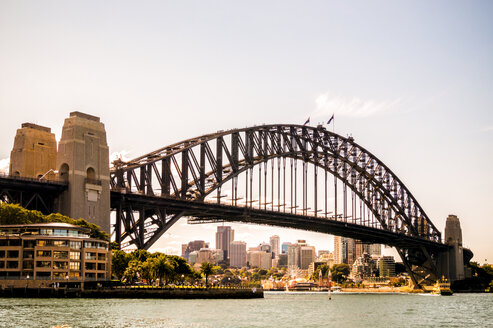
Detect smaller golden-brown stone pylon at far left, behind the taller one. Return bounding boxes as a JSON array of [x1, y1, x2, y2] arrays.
[[9, 123, 57, 179]]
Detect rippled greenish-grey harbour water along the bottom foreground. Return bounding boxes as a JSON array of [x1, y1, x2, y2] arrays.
[[0, 292, 493, 328]]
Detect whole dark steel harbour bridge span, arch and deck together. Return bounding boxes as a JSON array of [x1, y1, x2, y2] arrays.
[[0, 114, 472, 286]]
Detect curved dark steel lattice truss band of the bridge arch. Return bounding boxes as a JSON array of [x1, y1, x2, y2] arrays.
[[111, 125, 441, 250]]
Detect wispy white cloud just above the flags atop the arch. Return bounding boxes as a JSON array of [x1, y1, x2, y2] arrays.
[[311, 91, 401, 118]]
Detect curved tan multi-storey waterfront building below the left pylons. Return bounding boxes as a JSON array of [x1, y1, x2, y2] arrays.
[[0, 223, 111, 287]]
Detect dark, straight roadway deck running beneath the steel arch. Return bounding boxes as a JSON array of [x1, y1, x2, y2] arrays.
[[111, 191, 448, 251]]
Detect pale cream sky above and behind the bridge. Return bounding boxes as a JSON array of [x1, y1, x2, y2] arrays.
[[0, 0, 493, 263]]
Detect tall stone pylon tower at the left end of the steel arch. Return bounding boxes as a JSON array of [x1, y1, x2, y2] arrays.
[[57, 112, 110, 233]]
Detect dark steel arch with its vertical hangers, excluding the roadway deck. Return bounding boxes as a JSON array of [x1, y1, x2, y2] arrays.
[[111, 125, 441, 248]]
